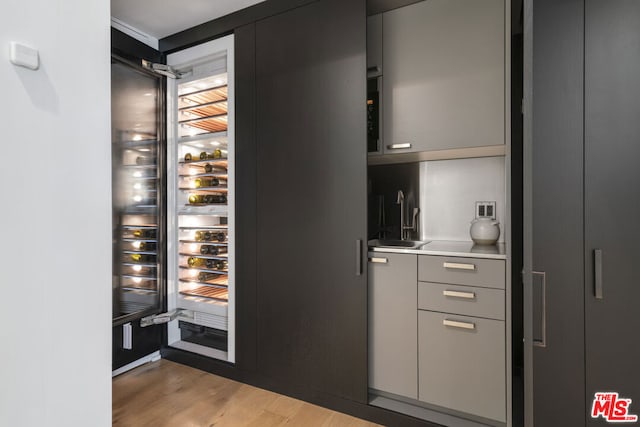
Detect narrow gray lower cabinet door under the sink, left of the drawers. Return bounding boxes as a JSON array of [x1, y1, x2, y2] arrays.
[[368, 252, 418, 399]]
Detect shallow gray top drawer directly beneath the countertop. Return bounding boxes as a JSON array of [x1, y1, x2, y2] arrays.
[[418, 255, 505, 289]]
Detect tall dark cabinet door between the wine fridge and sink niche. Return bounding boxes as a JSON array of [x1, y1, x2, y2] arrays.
[[255, 0, 367, 402]]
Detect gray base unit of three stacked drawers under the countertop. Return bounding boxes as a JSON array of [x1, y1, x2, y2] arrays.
[[418, 255, 507, 422]]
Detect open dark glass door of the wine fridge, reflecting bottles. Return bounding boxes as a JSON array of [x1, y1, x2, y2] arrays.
[[111, 56, 164, 326]]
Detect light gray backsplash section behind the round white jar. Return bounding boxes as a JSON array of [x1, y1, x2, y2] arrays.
[[419, 157, 506, 242]]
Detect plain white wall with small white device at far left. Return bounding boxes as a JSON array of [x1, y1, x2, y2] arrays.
[[0, 0, 111, 427]]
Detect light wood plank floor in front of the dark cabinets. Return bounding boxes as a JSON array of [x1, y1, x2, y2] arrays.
[[112, 360, 376, 427]]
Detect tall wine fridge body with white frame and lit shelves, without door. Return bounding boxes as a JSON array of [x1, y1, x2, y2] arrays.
[[167, 36, 235, 362]]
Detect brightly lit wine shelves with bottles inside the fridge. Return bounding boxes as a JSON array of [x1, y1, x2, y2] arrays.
[[177, 75, 229, 315]]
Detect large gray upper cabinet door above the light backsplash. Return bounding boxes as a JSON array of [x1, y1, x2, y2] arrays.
[[382, 0, 505, 154]]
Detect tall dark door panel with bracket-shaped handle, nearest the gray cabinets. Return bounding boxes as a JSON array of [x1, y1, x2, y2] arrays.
[[532, 0, 586, 427]]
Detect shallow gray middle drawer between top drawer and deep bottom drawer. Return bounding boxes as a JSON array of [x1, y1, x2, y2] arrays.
[[418, 282, 505, 320]]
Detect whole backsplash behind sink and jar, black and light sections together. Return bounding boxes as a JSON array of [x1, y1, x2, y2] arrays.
[[369, 157, 505, 242]]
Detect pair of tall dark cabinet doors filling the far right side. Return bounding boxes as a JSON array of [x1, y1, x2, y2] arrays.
[[527, 0, 640, 427]]
